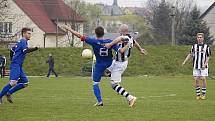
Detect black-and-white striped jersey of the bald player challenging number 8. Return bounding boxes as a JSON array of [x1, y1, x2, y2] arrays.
[[115, 34, 135, 62]]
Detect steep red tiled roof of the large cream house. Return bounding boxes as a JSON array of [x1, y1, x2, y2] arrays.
[[14, 0, 84, 34]]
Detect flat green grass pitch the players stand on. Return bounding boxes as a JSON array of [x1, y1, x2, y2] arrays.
[[0, 76, 215, 121]]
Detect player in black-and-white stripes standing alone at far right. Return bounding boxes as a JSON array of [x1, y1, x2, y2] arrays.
[[182, 33, 211, 100]]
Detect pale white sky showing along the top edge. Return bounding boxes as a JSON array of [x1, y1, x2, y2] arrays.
[[84, 0, 215, 10]]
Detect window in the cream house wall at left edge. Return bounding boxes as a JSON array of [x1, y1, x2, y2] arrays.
[[0, 22, 12, 34]]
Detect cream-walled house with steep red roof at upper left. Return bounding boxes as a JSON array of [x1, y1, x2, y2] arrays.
[[0, 0, 84, 48]]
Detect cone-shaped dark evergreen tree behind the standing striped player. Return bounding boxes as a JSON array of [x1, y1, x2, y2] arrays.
[[178, 6, 213, 44]]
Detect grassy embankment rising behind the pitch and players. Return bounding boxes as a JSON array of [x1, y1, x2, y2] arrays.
[[0, 46, 215, 76]]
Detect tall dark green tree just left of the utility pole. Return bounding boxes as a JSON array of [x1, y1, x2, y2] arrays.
[[149, 0, 171, 44]]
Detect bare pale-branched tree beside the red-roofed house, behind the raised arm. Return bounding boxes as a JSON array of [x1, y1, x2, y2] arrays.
[[65, 0, 101, 46]]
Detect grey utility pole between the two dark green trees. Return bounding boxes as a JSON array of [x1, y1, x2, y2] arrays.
[[170, 6, 176, 45]]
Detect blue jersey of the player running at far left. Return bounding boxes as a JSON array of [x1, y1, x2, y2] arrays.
[[11, 38, 28, 65]]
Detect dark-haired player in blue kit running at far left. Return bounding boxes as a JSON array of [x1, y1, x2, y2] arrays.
[[0, 28, 38, 104]]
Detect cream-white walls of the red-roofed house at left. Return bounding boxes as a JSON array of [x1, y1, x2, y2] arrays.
[[4, 0, 83, 47]]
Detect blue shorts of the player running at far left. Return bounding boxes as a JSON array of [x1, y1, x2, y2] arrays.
[[10, 64, 28, 83]]
